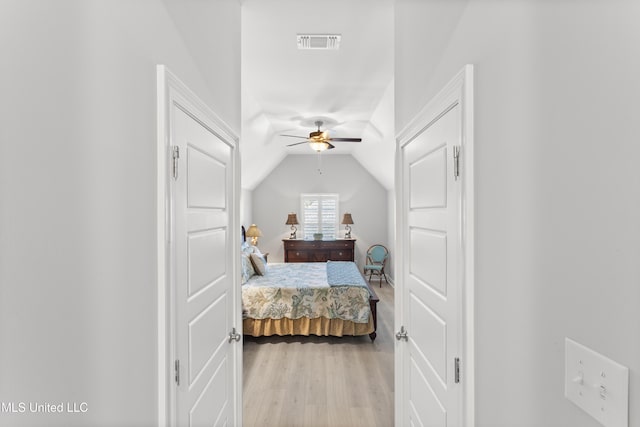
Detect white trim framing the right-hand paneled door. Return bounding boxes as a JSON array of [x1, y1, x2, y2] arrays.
[[395, 65, 475, 427]]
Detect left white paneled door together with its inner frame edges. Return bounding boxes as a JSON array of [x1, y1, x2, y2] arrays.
[[158, 67, 242, 427]]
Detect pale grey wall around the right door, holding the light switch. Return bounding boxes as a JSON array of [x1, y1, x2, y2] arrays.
[[396, 0, 640, 427]]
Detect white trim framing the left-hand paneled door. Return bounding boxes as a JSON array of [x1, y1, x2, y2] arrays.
[[156, 65, 242, 427]]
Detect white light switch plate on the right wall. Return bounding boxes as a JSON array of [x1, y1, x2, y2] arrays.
[[564, 338, 629, 427]]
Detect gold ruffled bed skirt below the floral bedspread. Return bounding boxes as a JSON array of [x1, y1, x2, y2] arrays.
[[242, 316, 375, 339]]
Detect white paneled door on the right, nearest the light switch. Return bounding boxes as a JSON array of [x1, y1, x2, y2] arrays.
[[397, 65, 472, 427]]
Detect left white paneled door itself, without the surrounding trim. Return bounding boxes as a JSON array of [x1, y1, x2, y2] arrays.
[[172, 104, 233, 427]]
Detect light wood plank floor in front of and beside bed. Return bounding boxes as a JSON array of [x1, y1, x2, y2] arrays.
[[243, 280, 394, 427]]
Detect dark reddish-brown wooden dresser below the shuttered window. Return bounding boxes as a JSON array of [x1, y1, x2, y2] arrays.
[[282, 239, 356, 262]]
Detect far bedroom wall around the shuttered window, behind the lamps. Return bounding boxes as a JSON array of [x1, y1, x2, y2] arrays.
[[249, 154, 393, 274]]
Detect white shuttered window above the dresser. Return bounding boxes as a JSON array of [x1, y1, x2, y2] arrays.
[[300, 194, 338, 239]]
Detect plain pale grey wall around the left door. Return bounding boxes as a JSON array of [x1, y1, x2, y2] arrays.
[[0, 0, 240, 426]]
